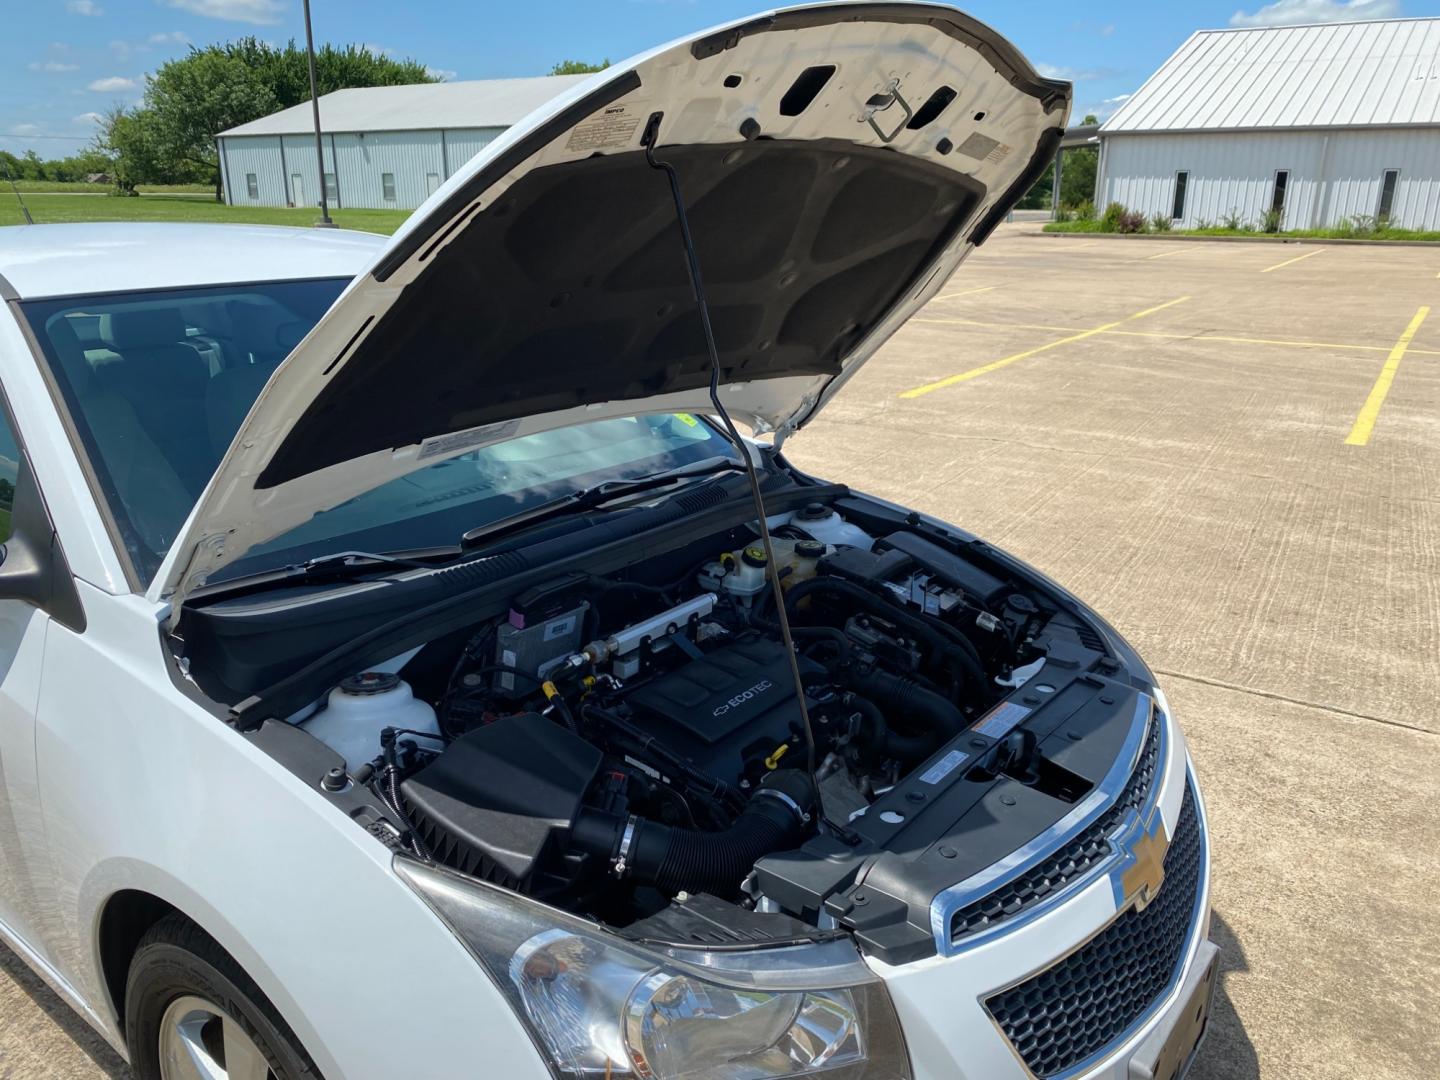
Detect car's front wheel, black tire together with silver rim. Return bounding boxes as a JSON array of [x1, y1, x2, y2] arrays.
[[125, 914, 320, 1080]]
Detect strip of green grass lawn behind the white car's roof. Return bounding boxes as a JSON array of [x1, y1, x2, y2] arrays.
[[0, 194, 410, 233]]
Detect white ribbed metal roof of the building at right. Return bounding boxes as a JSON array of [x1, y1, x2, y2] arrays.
[[1100, 19, 1440, 134]]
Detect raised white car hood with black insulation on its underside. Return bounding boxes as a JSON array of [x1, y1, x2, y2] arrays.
[[151, 3, 1070, 606]]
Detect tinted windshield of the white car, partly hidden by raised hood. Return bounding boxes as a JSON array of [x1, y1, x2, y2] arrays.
[[24, 279, 733, 580]]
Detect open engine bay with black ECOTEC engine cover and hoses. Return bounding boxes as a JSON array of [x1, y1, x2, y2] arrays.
[[267, 500, 1119, 958]]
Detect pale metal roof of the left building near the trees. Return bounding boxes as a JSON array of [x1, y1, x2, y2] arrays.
[[219, 75, 590, 137]]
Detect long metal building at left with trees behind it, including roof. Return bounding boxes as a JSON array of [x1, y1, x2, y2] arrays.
[[216, 75, 588, 210]]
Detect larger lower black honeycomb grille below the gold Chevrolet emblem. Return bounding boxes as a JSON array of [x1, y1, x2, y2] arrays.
[[985, 783, 1201, 1077]]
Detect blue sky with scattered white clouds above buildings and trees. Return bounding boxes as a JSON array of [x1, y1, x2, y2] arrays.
[[0, 0, 1440, 157]]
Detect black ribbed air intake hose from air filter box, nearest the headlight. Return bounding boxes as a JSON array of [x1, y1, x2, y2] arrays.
[[570, 769, 815, 896]]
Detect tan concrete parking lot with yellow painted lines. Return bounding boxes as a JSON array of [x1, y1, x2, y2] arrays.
[[0, 223, 1440, 1080]]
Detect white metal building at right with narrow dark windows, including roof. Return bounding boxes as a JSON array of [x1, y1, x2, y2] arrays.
[[1096, 19, 1440, 229]]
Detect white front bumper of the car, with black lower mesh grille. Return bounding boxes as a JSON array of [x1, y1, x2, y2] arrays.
[[871, 696, 1217, 1080]]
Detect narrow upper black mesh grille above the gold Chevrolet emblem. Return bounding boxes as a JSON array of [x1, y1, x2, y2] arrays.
[[950, 708, 1161, 943]]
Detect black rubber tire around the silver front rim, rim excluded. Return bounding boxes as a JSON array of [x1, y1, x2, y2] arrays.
[[125, 930, 318, 1080]]
